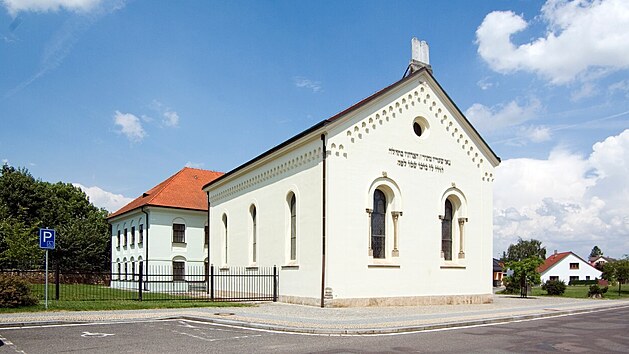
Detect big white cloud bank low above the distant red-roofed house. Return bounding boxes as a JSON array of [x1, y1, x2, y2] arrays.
[[494, 129, 629, 256]]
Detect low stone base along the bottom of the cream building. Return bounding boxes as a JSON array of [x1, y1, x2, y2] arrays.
[[278, 294, 494, 307]]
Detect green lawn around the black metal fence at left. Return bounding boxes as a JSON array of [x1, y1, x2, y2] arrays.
[[0, 284, 250, 313]]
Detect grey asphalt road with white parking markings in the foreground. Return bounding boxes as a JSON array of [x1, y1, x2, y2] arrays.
[[0, 308, 629, 354]]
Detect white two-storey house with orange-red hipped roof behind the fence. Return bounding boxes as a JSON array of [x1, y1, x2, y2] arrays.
[[107, 167, 222, 286]]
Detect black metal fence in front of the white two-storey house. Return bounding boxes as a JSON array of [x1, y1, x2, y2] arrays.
[[0, 263, 279, 301]]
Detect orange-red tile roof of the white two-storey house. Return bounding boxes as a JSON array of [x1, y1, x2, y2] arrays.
[[107, 167, 223, 219]]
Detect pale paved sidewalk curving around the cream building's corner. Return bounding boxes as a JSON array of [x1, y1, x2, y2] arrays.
[[0, 295, 629, 335]]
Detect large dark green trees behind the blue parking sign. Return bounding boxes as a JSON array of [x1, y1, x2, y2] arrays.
[[0, 164, 111, 271]]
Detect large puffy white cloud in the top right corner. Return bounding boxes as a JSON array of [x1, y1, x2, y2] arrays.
[[476, 0, 629, 84]]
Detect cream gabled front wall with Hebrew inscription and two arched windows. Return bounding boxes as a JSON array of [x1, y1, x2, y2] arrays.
[[327, 76, 494, 299]]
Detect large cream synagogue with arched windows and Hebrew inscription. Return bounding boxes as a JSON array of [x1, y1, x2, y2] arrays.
[[203, 39, 500, 307]]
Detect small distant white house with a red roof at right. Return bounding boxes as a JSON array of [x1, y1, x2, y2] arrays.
[[537, 251, 602, 284]]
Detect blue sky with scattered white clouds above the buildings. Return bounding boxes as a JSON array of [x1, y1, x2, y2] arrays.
[[0, 0, 629, 256]]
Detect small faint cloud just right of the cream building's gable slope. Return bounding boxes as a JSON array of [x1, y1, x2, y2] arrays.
[[465, 98, 541, 133]]
